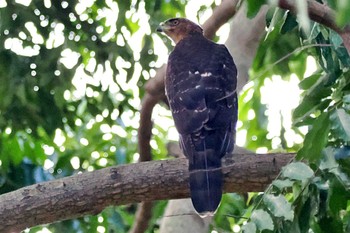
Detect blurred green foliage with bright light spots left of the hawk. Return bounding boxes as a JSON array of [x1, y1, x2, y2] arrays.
[[0, 0, 185, 232]]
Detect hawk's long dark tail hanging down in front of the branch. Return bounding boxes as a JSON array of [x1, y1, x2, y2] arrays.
[[189, 149, 222, 216]]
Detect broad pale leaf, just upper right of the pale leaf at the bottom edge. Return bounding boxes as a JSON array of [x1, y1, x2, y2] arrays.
[[264, 194, 294, 221]]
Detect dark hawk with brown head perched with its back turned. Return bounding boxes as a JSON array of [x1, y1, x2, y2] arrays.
[[157, 18, 237, 216]]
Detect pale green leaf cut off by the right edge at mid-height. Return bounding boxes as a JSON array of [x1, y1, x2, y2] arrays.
[[330, 108, 350, 142]]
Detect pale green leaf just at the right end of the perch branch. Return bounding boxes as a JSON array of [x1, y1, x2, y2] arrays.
[[282, 162, 314, 181]]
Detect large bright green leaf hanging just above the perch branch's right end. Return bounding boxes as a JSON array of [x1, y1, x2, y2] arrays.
[[296, 112, 330, 161]]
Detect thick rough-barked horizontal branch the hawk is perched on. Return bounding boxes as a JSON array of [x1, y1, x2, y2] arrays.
[[0, 154, 294, 232]]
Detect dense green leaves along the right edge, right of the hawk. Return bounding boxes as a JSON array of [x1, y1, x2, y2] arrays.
[[238, 1, 350, 232]]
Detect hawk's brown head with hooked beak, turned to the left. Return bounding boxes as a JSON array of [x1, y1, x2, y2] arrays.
[[157, 18, 203, 44]]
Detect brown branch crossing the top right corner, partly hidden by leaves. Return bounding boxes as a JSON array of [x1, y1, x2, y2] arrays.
[[278, 0, 350, 53]]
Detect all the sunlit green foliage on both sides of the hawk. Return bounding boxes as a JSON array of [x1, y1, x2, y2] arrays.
[[0, 0, 350, 232]]
